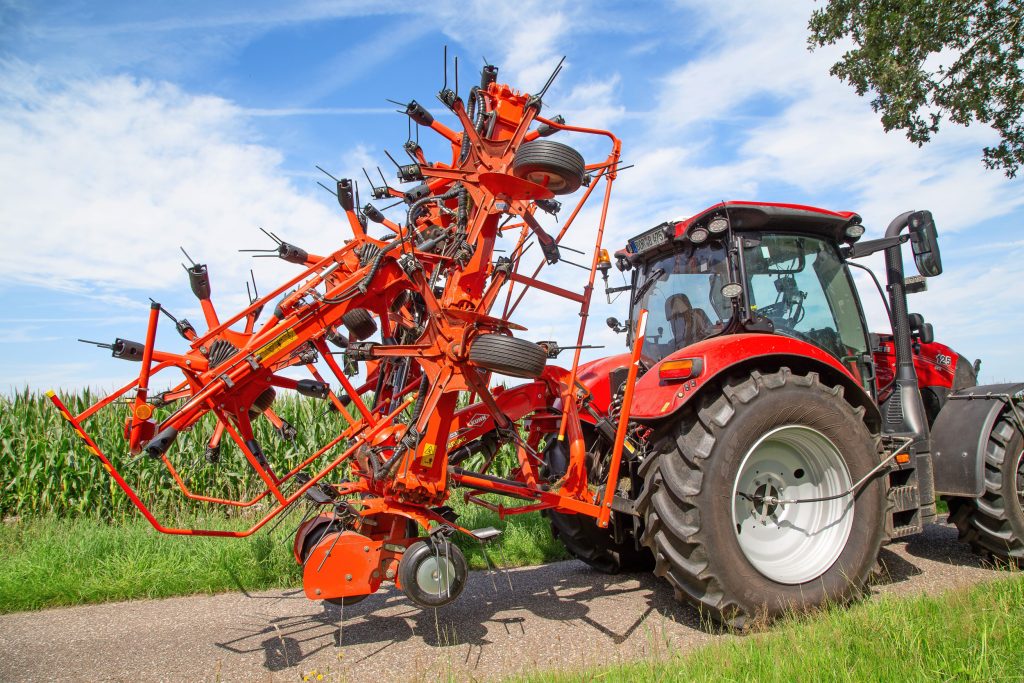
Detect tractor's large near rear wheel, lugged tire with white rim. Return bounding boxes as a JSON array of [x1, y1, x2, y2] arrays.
[[638, 368, 885, 628]]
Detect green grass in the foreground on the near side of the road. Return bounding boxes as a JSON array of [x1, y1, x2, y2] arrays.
[[515, 577, 1024, 683]]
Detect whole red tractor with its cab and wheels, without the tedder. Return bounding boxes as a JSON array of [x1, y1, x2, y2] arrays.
[[565, 202, 1024, 621]]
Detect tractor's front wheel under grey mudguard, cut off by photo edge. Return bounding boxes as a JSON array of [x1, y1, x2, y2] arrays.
[[946, 415, 1024, 568]]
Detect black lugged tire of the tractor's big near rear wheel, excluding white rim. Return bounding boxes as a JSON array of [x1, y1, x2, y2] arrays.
[[637, 368, 886, 629]]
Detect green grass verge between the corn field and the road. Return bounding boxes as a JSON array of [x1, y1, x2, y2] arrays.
[[0, 497, 566, 613]]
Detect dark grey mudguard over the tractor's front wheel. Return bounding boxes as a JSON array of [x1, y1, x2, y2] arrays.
[[932, 383, 1024, 498]]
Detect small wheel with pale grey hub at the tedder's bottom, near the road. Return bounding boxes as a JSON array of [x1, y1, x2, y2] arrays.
[[398, 539, 469, 607]]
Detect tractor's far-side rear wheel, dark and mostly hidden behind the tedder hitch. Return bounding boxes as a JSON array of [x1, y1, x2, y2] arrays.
[[544, 423, 654, 573]]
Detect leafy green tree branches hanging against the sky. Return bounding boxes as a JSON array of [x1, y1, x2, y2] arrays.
[[808, 0, 1024, 178]]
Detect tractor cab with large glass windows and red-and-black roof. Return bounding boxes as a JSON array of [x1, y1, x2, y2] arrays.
[[616, 202, 868, 377]]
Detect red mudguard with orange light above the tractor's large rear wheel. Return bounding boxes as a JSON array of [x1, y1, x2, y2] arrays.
[[630, 334, 880, 425]]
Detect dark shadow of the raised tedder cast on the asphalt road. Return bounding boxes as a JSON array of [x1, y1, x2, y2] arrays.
[[216, 564, 700, 672]]
